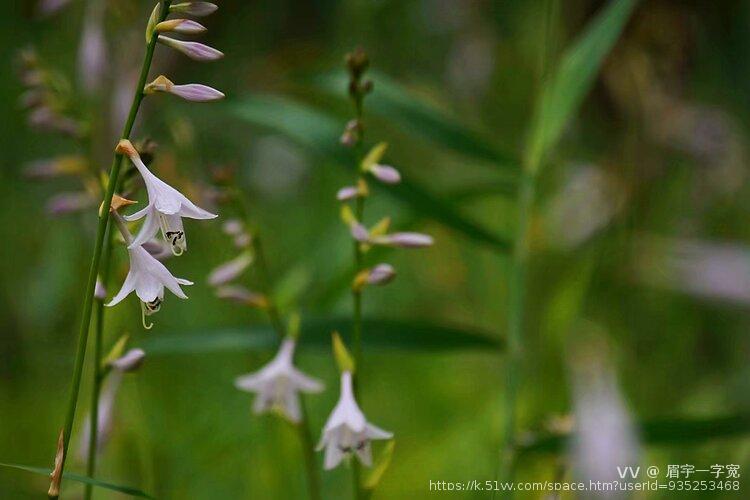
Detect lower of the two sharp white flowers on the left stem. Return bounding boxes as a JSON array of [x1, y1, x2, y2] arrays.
[[106, 246, 193, 329]]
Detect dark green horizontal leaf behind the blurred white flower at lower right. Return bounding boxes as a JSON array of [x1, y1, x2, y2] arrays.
[[518, 415, 750, 454]]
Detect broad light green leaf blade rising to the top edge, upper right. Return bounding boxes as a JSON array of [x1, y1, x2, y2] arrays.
[[525, 0, 637, 172]]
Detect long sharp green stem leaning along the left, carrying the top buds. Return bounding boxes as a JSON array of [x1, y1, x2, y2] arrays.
[[48, 0, 171, 499]]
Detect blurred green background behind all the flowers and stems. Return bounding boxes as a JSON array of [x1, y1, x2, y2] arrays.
[[0, 0, 750, 499]]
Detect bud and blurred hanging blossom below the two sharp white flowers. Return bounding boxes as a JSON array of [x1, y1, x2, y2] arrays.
[[78, 335, 146, 461]]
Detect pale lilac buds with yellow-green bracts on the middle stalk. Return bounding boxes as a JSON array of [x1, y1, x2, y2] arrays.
[[336, 143, 433, 290]]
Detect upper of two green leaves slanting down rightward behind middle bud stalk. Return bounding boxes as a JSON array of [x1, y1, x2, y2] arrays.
[[313, 71, 519, 171]]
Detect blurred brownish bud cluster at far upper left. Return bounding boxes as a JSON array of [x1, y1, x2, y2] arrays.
[[19, 48, 86, 138]]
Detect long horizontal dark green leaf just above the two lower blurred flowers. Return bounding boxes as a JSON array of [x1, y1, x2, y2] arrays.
[[141, 318, 504, 356]]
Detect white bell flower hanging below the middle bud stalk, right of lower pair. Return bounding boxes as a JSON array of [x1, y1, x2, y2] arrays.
[[317, 371, 393, 470]]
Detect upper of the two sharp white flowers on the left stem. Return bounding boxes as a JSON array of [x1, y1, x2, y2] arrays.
[[117, 141, 217, 255]]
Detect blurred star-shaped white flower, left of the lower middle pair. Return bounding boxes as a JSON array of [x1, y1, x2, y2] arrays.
[[234, 338, 323, 423]]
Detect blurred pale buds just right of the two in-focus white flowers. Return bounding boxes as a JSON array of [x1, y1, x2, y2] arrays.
[[208, 219, 268, 309]]
